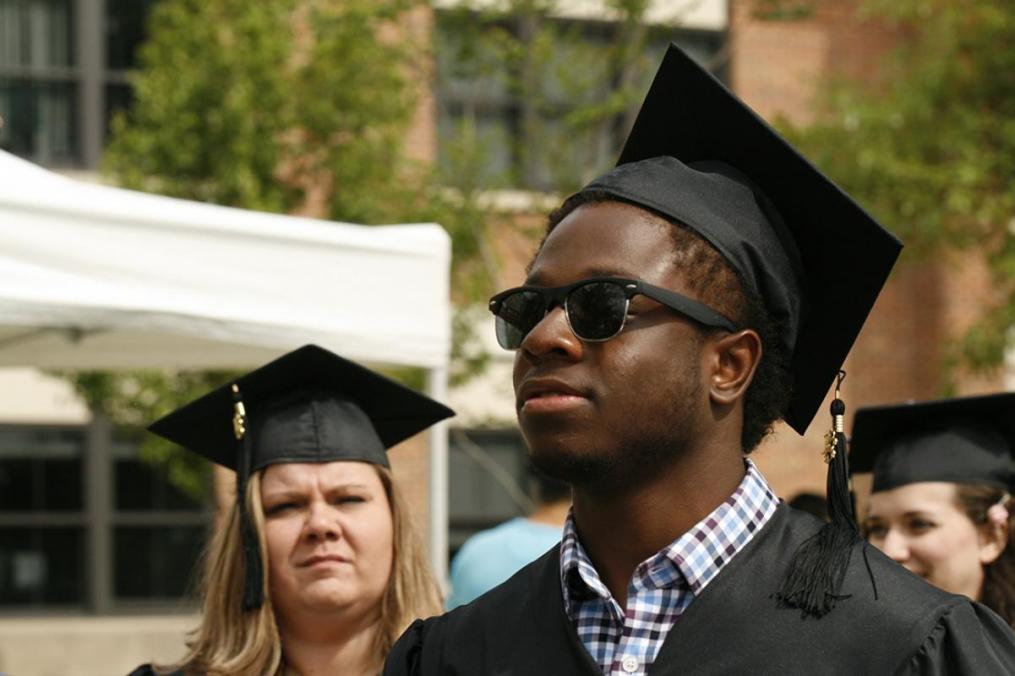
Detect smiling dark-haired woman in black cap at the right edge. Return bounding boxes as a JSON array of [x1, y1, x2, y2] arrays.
[[852, 394, 1015, 625]]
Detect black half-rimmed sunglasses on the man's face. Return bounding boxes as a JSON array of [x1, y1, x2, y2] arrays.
[[490, 277, 737, 350]]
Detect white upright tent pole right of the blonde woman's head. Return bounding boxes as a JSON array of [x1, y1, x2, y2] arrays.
[[426, 365, 448, 589]]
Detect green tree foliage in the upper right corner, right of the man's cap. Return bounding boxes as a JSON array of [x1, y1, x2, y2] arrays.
[[783, 0, 1015, 368]]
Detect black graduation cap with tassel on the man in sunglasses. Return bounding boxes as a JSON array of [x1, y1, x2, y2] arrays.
[[583, 45, 901, 617]]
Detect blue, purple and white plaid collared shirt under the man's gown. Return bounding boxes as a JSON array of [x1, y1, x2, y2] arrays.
[[560, 460, 779, 676]]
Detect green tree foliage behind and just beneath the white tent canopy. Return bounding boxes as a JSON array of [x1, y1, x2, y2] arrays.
[[68, 0, 434, 494]]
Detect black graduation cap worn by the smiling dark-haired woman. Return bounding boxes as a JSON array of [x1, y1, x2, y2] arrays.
[[850, 393, 1015, 492]]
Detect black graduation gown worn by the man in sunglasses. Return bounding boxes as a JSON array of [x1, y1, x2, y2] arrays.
[[384, 503, 1015, 676]]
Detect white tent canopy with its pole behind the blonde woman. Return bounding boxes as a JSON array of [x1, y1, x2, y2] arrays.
[[0, 151, 451, 573]]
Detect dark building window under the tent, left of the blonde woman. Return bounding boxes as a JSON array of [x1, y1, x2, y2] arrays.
[[0, 424, 211, 612]]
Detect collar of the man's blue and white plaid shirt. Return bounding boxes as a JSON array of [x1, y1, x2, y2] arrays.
[[560, 459, 779, 615]]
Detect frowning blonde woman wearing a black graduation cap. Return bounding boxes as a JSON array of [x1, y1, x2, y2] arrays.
[[125, 345, 454, 676]]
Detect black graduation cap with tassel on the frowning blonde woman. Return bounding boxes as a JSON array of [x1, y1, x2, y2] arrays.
[[148, 345, 455, 611]]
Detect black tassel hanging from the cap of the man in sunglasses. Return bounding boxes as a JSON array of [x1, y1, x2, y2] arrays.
[[775, 371, 873, 618]]
